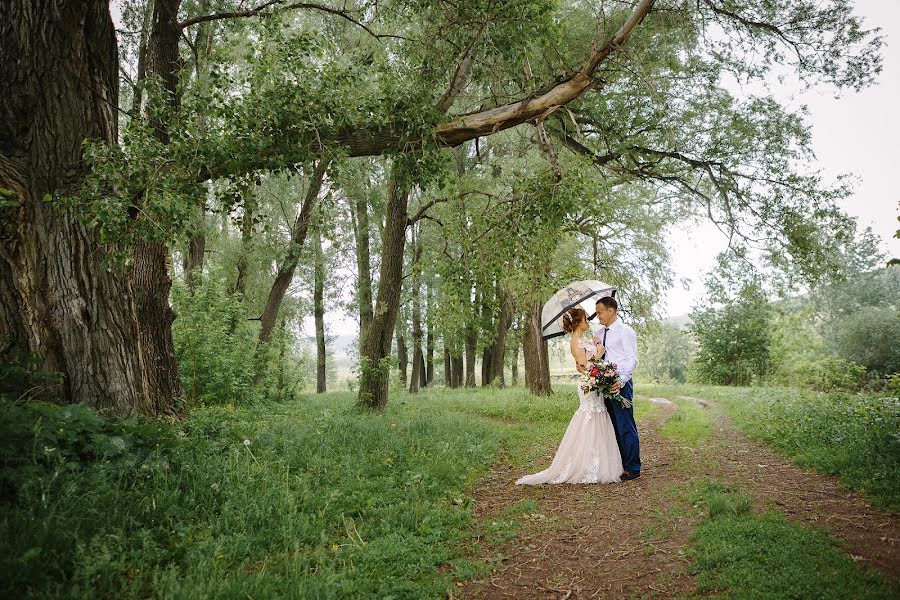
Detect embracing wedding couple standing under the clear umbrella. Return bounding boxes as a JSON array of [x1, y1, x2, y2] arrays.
[[516, 297, 641, 485]]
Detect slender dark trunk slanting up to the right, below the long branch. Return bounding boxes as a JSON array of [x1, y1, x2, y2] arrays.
[[259, 160, 328, 344]]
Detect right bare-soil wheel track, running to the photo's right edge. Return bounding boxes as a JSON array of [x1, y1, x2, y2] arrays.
[[700, 417, 900, 578]]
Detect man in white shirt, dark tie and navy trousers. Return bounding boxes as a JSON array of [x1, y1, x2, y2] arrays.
[[594, 296, 641, 481]]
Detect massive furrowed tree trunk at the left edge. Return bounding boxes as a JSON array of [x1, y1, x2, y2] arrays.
[[0, 0, 153, 415]]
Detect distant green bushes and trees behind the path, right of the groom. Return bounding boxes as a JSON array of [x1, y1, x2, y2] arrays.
[[641, 252, 900, 390]]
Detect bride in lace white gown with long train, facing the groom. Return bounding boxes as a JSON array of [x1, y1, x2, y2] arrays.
[[516, 307, 622, 485]]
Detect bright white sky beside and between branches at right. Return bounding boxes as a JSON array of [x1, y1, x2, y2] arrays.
[[660, 0, 900, 316]]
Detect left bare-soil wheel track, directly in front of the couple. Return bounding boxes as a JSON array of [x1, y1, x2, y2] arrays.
[[456, 405, 693, 600]]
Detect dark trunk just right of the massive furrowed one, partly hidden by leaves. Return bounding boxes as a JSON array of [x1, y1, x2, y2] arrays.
[[134, 0, 184, 412]]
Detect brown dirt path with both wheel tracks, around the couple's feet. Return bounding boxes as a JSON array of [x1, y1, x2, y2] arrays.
[[456, 399, 900, 599]]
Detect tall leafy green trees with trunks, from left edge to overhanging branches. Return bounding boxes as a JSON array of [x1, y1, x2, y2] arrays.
[[0, 0, 882, 414]]
